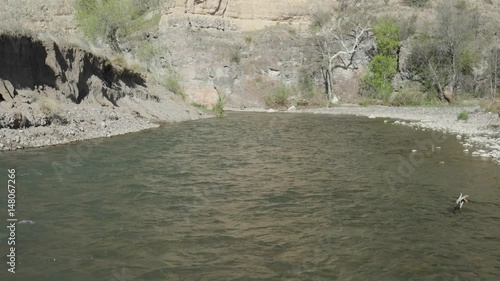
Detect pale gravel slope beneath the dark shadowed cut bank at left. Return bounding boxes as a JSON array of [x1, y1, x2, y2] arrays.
[[0, 91, 209, 151]]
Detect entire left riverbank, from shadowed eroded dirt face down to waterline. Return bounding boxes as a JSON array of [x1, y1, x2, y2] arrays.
[[0, 34, 203, 149]]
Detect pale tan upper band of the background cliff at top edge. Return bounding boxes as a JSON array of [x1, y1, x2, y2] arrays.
[[160, 0, 309, 30]]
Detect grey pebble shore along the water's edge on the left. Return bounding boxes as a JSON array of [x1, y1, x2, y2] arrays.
[[0, 98, 209, 151]]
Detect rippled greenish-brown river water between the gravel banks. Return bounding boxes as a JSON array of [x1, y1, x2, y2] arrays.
[[0, 113, 500, 281]]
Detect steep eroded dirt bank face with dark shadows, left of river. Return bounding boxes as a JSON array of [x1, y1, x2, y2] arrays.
[[0, 34, 146, 106]]
